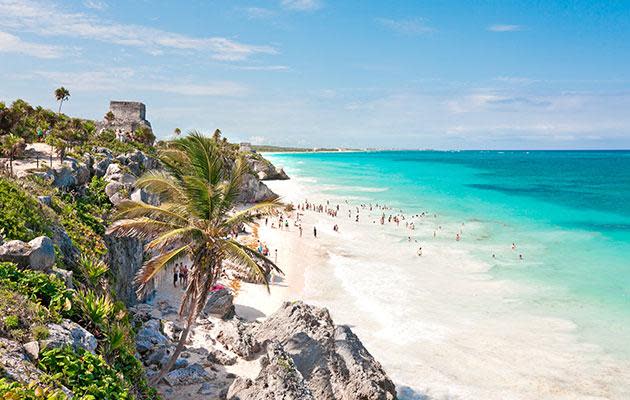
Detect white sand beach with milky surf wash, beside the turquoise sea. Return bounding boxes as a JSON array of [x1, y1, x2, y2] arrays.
[[235, 177, 630, 399]]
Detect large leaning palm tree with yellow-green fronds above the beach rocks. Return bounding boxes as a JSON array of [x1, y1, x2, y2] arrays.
[[108, 132, 282, 383]]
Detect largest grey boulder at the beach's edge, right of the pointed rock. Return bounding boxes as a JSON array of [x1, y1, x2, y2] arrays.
[[250, 301, 396, 400]]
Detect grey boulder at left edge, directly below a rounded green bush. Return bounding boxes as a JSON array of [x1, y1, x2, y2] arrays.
[[0, 236, 55, 271]]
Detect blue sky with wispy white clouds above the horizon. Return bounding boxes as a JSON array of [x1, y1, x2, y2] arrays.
[[0, 0, 630, 149]]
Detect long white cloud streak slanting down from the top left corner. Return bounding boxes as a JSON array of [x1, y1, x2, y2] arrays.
[[0, 0, 277, 61]]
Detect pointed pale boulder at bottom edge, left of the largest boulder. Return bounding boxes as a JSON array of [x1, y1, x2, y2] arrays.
[[227, 343, 318, 400]]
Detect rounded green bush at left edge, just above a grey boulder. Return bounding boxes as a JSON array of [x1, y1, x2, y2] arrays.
[[0, 178, 50, 242]]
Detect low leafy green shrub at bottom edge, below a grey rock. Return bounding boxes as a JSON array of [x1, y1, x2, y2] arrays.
[[38, 347, 131, 400]]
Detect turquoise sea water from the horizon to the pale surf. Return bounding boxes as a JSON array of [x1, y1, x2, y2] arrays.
[[269, 151, 630, 357]]
